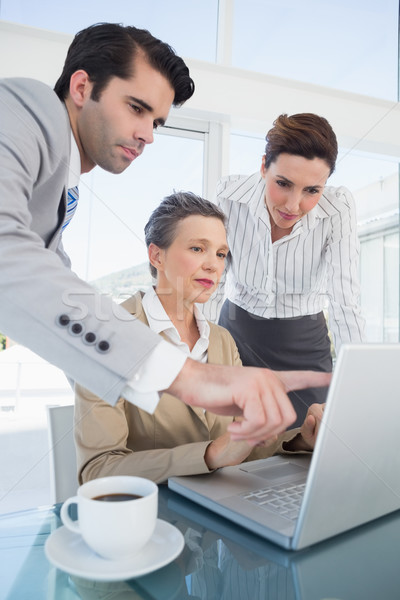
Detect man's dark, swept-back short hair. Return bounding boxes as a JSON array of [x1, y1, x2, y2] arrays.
[[54, 23, 194, 106]]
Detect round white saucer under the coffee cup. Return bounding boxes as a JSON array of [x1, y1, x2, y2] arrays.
[[44, 519, 185, 581]]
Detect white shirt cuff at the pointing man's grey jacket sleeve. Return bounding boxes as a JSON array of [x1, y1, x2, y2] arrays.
[[121, 340, 187, 414]]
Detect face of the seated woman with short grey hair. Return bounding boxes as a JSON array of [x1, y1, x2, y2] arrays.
[[149, 215, 229, 304]]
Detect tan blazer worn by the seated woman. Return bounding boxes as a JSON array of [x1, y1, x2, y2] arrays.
[[75, 295, 241, 483]]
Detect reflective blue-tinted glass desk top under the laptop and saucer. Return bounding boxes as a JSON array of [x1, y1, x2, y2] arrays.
[[0, 486, 400, 600]]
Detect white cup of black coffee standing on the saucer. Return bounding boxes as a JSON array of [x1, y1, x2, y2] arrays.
[[61, 475, 158, 560]]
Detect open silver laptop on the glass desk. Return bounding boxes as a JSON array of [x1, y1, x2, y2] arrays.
[[168, 344, 400, 550]]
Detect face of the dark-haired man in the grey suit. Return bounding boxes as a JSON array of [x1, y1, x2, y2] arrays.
[[75, 56, 174, 173]]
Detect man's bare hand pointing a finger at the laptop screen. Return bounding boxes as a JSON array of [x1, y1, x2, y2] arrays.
[[166, 358, 331, 444]]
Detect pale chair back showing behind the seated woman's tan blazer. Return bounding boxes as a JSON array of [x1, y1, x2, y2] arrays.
[[47, 404, 79, 503]]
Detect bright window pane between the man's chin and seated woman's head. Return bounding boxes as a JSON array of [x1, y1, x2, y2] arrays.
[[64, 128, 205, 281]]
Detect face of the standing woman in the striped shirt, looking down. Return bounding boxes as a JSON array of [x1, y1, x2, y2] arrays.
[[261, 153, 330, 234]]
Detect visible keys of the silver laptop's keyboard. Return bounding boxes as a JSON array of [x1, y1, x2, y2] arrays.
[[240, 483, 306, 521]]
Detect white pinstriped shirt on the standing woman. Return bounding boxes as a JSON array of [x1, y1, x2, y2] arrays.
[[203, 173, 364, 352]]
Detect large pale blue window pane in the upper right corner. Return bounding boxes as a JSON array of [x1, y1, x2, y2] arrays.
[[233, 0, 399, 101]]
